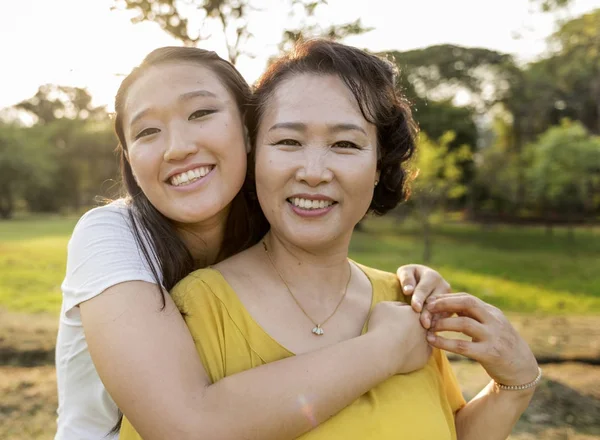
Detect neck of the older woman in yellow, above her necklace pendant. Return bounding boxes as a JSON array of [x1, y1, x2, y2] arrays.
[[261, 231, 351, 301]]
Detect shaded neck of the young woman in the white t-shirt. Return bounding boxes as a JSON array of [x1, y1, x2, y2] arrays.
[[175, 209, 229, 269]]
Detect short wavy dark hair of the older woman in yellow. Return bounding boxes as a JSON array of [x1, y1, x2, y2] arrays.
[[246, 39, 417, 215]]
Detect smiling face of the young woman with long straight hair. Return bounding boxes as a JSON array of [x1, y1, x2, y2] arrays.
[[123, 63, 247, 224]]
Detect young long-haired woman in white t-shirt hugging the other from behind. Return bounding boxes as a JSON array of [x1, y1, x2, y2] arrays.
[[56, 48, 448, 439]]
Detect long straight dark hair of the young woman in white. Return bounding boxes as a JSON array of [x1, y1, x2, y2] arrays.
[[115, 47, 266, 307]]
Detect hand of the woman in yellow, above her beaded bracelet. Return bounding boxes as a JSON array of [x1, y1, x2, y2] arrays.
[[426, 293, 538, 385]]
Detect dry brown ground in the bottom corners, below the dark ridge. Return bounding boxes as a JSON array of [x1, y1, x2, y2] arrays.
[[0, 362, 600, 440]]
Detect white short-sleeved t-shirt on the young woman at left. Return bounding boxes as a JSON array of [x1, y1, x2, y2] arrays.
[[55, 200, 160, 440]]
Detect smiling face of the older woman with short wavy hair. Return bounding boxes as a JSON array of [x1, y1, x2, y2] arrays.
[[256, 74, 378, 249]]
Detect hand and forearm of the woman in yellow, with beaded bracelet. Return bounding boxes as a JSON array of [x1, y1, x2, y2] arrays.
[[427, 294, 539, 440]]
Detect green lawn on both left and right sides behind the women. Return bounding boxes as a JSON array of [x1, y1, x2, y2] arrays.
[[0, 217, 600, 314]]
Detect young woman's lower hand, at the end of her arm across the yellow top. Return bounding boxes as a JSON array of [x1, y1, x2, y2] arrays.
[[368, 301, 432, 374]]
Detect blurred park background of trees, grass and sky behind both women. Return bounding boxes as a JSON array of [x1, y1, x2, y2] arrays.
[[0, 0, 600, 440]]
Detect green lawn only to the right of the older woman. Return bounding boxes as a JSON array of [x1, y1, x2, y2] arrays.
[[351, 218, 600, 314]]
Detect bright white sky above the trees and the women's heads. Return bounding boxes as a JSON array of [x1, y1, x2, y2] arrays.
[[0, 0, 600, 111]]
